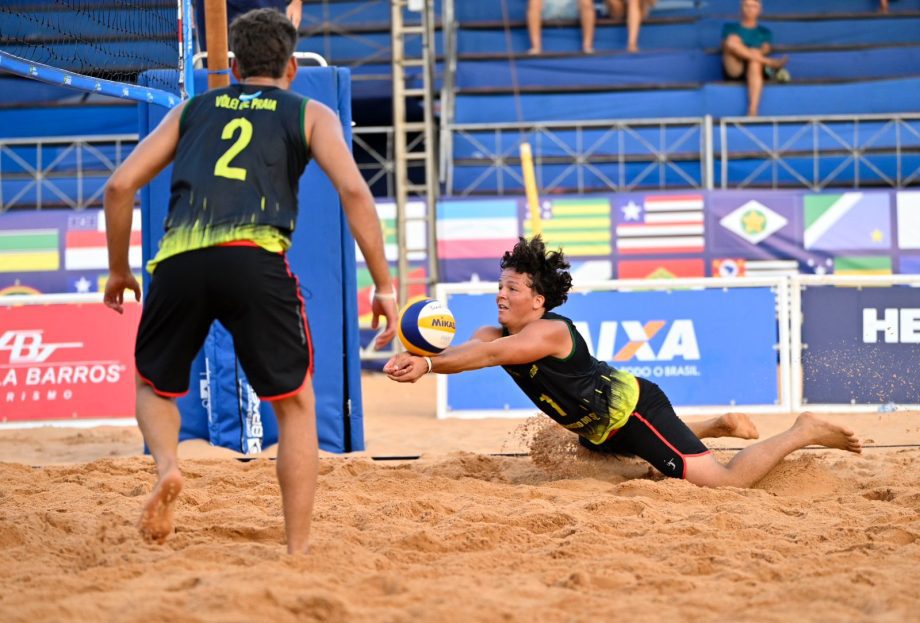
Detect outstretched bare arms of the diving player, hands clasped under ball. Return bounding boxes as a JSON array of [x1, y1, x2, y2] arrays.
[[383, 320, 572, 383]]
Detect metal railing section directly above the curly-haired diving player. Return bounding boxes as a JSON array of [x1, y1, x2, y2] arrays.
[[447, 117, 712, 195]]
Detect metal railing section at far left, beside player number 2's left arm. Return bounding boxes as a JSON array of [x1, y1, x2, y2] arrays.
[[0, 134, 138, 213]]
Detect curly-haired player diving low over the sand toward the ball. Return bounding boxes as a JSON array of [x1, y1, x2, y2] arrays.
[[384, 236, 862, 487]]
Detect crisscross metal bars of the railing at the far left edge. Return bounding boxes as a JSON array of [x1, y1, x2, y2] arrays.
[[0, 134, 138, 214]]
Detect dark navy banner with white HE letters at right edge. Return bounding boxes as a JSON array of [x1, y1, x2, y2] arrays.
[[802, 286, 920, 404]]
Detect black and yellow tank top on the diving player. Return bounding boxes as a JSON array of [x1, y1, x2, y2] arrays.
[[502, 312, 639, 444]]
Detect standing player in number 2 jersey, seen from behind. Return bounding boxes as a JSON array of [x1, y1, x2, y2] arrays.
[[105, 9, 396, 553]]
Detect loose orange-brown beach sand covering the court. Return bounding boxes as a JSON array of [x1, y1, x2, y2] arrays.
[[0, 375, 920, 623]]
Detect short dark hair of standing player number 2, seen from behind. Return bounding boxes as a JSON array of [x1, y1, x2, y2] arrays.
[[230, 9, 297, 78]]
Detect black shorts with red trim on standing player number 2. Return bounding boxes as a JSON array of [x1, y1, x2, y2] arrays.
[[134, 246, 313, 400]]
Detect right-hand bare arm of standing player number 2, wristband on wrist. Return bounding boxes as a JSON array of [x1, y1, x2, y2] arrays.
[[304, 100, 397, 348]]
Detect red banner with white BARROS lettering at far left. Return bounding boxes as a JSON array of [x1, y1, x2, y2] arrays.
[[0, 302, 141, 422]]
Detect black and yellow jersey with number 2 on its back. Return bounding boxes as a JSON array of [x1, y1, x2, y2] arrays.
[[147, 84, 310, 272]]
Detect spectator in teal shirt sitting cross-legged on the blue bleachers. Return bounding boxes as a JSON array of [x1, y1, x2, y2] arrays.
[[722, 0, 789, 117]]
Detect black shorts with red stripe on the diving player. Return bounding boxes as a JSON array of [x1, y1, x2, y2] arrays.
[[578, 378, 710, 478]]
